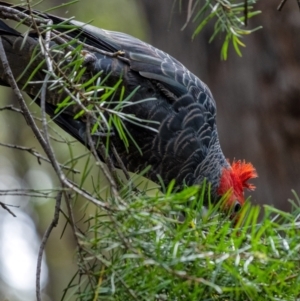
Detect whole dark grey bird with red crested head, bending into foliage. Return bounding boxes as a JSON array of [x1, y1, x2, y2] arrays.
[[0, 1, 257, 212]]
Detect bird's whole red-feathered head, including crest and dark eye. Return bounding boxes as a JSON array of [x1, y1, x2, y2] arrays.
[[217, 161, 257, 214]]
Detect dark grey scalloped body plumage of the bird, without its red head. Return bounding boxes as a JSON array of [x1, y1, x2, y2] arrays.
[[0, 1, 229, 200]]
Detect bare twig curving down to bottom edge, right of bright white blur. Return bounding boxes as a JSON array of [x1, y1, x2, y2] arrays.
[[36, 191, 63, 301]]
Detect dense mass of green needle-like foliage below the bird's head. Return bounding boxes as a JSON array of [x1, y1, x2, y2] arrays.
[[63, 185, 300, 301]]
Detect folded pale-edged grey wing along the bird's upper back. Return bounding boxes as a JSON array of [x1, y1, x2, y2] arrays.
[[72, 21, 216, 115]]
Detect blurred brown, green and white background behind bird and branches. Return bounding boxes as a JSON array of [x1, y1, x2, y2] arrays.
[[0, 0, 300, 301]]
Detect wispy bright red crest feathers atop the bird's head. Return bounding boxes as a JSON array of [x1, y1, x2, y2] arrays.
[[231, 160, 257, 190]]
